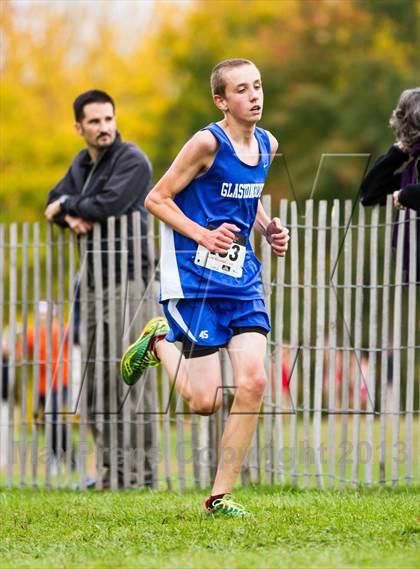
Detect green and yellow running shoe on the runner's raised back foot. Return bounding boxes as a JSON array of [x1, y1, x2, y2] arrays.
[[120, 316, 169, 385]]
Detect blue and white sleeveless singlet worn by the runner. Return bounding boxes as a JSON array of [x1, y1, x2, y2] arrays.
[[161, 123, 270, 301]]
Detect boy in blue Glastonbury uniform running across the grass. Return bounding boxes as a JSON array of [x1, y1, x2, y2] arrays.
[[121, 59, 289, 517]]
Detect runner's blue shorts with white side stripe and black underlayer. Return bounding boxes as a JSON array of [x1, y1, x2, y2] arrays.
[[163, 298, 271, 357]]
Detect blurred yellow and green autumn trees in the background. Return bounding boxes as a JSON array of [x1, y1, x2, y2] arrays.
[[0, 0, 419, 221]]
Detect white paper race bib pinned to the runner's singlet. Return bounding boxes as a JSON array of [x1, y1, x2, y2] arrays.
[[194, 230, 246, 278]]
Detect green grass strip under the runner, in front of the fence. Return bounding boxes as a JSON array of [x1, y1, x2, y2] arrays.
[[0, 487, 420, 569]]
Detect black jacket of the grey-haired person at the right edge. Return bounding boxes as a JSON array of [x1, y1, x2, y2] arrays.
[[360, 145, 420, 281]]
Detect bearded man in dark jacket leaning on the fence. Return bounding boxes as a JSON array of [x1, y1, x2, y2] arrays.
[[45, 90, 156, 488]]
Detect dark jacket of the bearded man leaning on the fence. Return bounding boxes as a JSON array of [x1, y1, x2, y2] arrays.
[[48, 135, 152, 287]]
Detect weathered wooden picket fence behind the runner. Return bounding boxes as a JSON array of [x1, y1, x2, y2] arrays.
[[0, 196, 420, 490]]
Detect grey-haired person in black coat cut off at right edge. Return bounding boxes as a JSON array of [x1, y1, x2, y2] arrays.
[[360, 87, 420, 285]]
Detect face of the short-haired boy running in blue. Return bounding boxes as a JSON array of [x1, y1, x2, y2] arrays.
[[223, 65, 264, 123]]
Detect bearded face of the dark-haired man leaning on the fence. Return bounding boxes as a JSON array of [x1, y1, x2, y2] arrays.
[[76, 103, 117, 150]]
